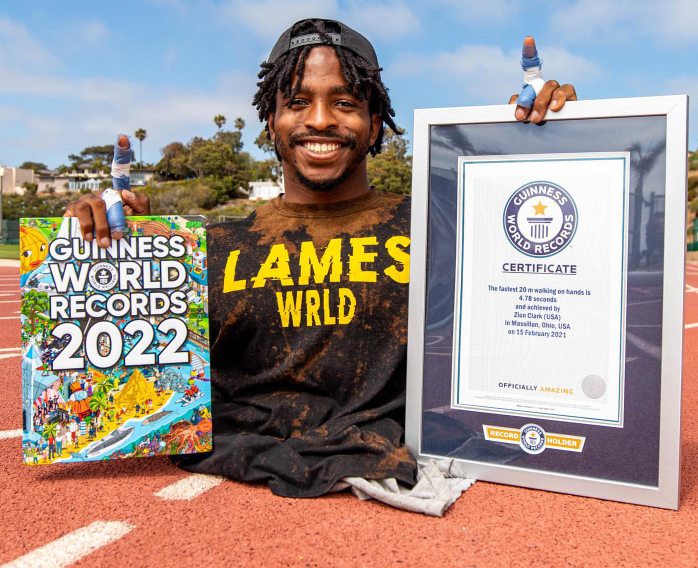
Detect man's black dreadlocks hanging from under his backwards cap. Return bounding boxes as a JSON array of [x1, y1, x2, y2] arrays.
[[252, 19, 402, 156]]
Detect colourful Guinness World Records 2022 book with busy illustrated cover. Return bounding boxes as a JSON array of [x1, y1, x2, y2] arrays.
[[20, 216, 213, 465]]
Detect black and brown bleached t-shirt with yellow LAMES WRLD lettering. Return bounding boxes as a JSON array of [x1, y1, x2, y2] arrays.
[[177, 190, 416, 497]]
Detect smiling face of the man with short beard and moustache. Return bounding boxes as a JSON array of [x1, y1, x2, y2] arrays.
[[269, 47, 381, 191]]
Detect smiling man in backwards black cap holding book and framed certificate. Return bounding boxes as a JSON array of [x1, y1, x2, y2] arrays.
[[66, 19, 576, 497]]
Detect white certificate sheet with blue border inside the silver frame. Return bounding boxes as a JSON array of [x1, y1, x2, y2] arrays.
[[452, 152, 630, 426]]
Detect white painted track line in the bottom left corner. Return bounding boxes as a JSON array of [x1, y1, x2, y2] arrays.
[[2, 521, 136, 568]]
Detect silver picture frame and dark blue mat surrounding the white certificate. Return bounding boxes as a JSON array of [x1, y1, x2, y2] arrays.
[[405, 95, 688, 509]]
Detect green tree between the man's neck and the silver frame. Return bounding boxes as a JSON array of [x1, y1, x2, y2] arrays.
[[367, 129, 412, 195]]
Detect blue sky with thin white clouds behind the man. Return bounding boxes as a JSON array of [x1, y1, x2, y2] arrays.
[[0, 0, 698, 167]]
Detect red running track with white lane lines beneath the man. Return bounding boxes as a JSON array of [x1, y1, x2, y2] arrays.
[[0, 264, 698, 568]]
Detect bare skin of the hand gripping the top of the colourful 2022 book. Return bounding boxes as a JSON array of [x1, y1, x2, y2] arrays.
[[63, 189, 150, 248]]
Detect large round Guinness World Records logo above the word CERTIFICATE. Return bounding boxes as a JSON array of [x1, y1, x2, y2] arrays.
[[504, 181, 578, 258]]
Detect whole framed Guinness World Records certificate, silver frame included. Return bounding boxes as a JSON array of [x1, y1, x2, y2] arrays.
[[406, 96, 688, 509]]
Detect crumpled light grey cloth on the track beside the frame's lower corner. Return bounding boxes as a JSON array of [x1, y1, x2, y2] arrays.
[[331, 459, 475, 517]]
